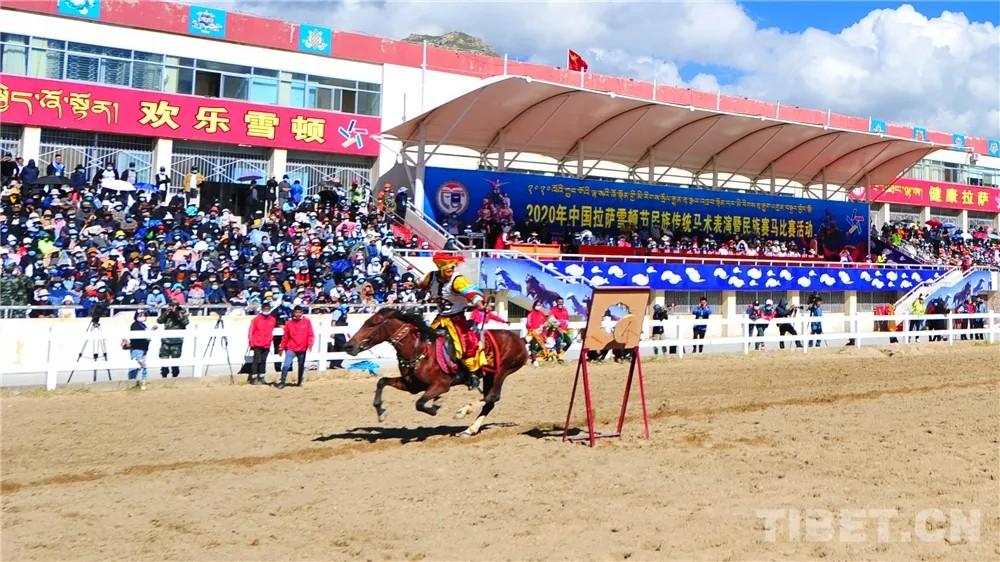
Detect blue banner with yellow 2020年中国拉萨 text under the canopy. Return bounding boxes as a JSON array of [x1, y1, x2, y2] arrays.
[[424, 168, 868, 261]]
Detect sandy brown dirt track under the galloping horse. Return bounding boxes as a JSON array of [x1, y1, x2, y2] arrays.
[[0, 344, 1000, 560]]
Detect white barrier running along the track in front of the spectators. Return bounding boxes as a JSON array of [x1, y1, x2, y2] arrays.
[[0, 313, 1000, 390]]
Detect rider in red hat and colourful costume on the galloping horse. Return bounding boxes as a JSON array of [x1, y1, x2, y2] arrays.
[[420, 252, 486, 388]]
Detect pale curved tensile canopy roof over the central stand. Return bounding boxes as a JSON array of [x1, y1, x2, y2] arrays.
[[384, 77, 940, 186]]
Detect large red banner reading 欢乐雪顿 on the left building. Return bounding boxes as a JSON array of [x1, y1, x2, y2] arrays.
[[0, 74, 381, 156]]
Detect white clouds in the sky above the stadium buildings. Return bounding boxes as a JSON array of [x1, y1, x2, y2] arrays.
[[211, 0, 1000, 136]]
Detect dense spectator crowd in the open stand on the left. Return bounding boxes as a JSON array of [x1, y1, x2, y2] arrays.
[[0, 153, 428, 317]]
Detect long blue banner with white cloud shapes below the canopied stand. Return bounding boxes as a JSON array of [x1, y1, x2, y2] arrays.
[[480, 258, 946, 296]]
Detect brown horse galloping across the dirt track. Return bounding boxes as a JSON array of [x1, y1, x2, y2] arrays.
[[344, 308, 528, 435]]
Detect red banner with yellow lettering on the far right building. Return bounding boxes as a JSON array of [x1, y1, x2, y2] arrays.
[[850, 178, 1000, 213]]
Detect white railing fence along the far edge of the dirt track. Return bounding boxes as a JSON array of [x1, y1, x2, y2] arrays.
[[0, 313, 1000, 390]]
